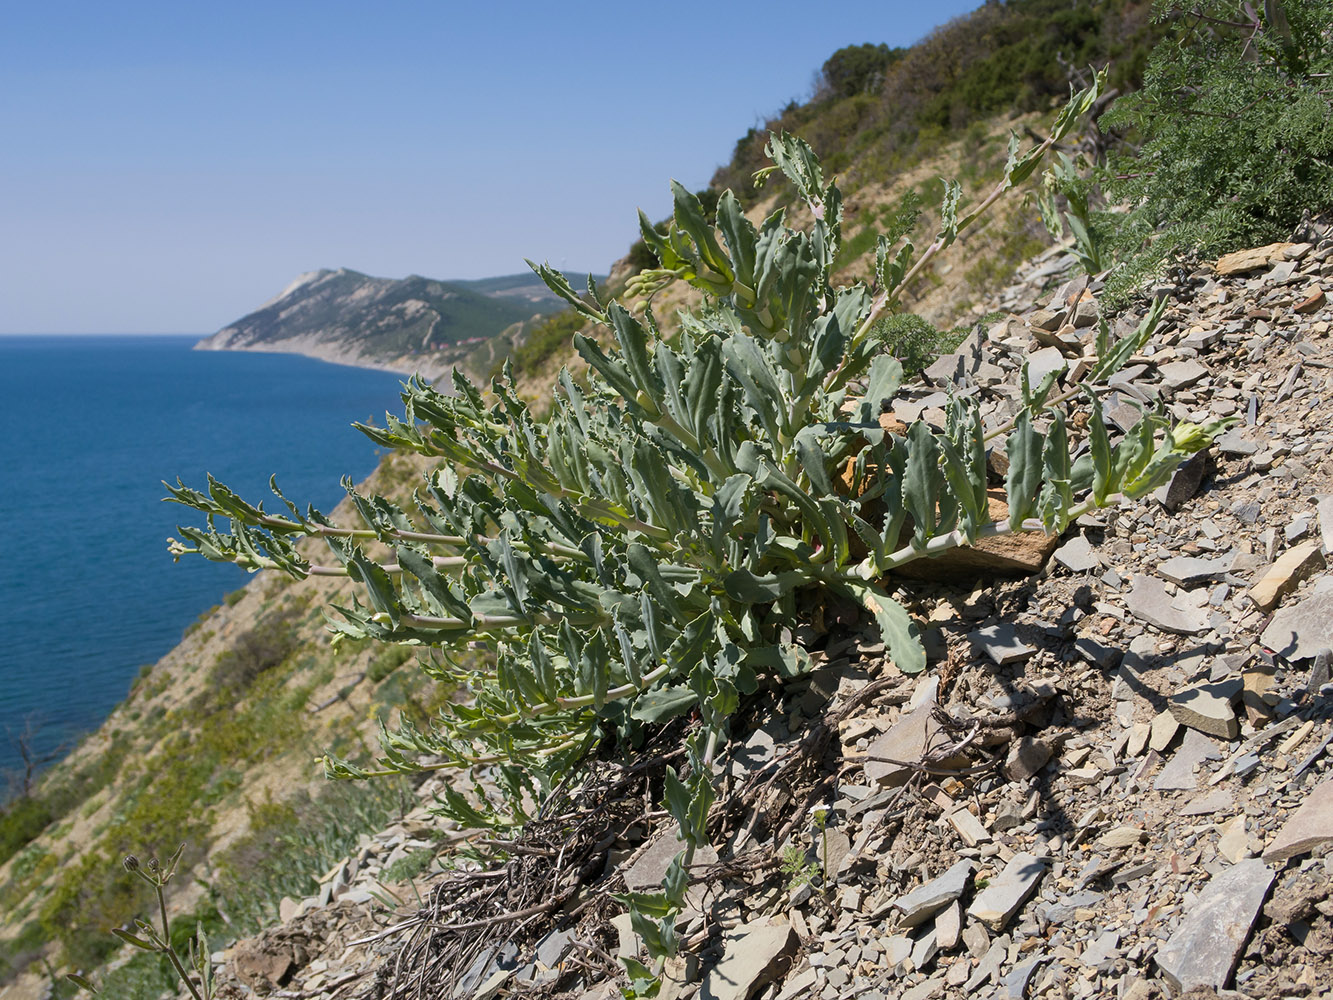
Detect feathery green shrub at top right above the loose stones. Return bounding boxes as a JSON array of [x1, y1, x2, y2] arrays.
[[1098, 0, 1333, 305]]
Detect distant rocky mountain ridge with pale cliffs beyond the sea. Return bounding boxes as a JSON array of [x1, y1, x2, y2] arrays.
[[195, 268, 589, 377]]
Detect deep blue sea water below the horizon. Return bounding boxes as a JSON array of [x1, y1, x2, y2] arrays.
[[0, 336, 399, 784]]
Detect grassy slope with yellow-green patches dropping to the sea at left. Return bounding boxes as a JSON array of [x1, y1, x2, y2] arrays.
[[0, 456, 440, 996]]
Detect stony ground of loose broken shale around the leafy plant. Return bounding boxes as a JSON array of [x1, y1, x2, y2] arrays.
[[193, 225, 1333, 1000]]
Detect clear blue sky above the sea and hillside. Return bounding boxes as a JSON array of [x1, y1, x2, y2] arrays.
[[0, 0, 977, 333]]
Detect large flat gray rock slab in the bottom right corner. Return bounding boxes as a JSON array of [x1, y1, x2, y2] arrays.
[[1157, 859, 1273, 992]]
